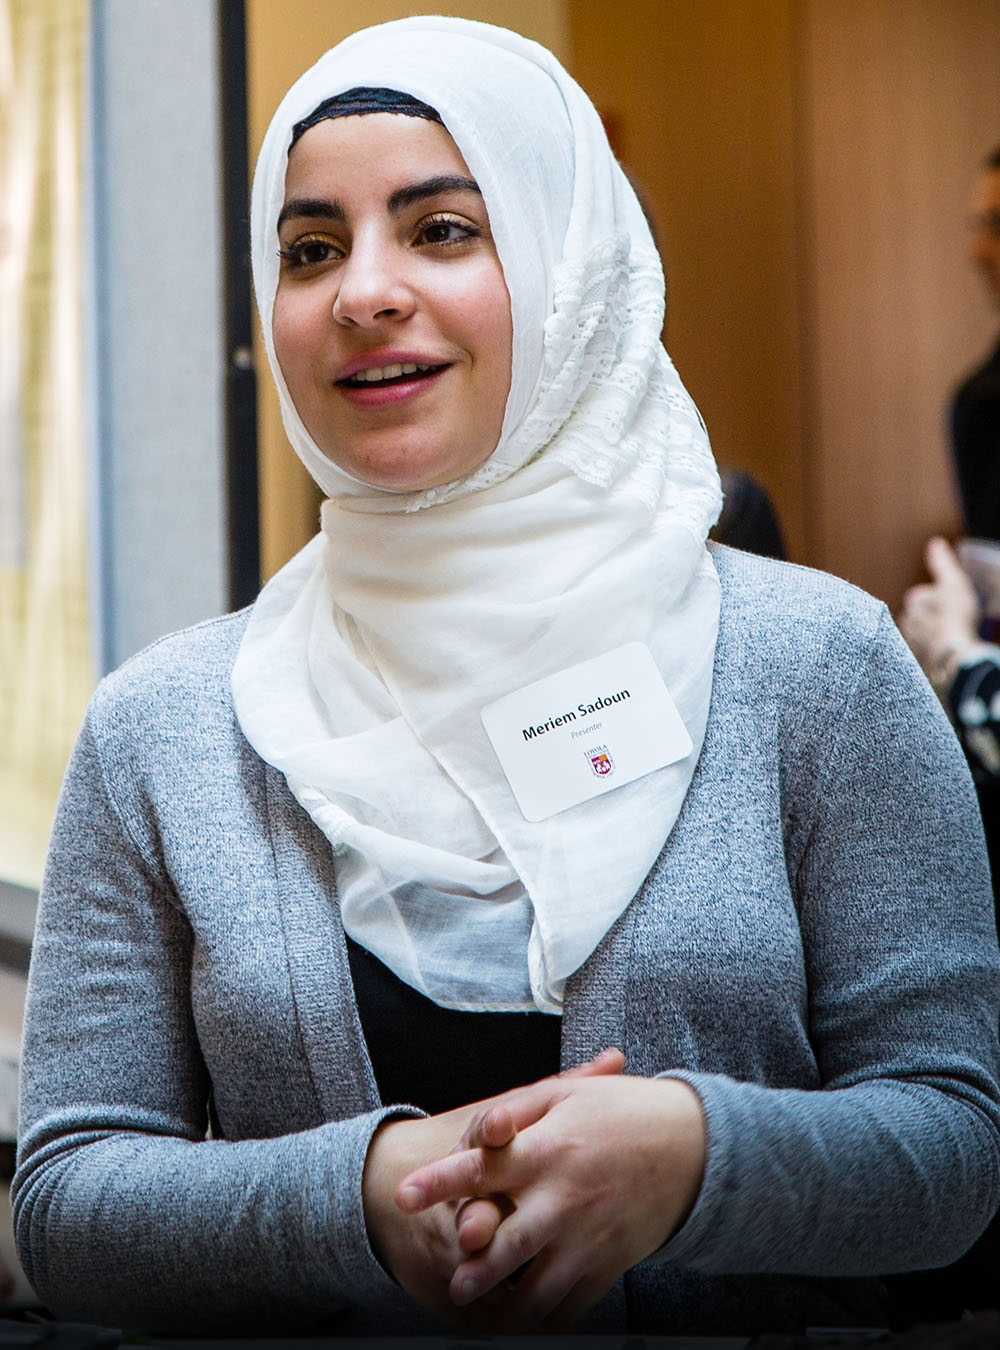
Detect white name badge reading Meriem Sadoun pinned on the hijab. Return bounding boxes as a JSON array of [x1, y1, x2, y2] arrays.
[[480, 643, 692, 821]]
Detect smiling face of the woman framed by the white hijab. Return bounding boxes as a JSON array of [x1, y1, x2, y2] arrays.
[[273, 113, 511, 491]]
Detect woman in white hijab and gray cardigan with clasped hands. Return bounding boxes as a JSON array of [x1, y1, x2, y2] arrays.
[[15, 18, 1000, 1334]]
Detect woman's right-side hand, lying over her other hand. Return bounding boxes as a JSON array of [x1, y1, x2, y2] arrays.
[[397, 1076, 706, 1332]]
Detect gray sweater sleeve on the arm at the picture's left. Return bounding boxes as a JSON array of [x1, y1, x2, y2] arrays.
[[12, 722, 418, 1334]]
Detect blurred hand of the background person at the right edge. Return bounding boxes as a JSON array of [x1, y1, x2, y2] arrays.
[[899, 536, 980, 690]]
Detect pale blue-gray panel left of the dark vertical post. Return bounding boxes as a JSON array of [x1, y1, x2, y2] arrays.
[[86, 0, 228, 658]]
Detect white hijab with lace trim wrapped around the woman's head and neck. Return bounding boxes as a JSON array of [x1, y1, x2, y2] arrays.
[[232, 18, 721, 1013]]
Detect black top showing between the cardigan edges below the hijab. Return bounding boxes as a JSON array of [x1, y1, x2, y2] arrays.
[[347, 937, 563, 1115]]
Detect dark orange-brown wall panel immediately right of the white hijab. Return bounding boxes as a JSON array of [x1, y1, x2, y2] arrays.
[[570, 0, 806, 556]]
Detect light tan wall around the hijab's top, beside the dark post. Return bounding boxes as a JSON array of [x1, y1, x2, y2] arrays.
[[247, 0, 570, 579]]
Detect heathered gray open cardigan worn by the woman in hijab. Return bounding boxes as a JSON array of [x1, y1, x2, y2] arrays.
[[13, 548, 1000, 1334]]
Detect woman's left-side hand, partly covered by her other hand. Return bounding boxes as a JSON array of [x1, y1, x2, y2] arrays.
[[362, 1050, 625, 1330]]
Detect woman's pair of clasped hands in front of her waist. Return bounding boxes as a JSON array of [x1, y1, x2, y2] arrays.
[[363, 1050, 706, 1334]]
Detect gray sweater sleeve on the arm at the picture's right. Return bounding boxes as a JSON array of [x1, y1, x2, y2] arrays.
[[656, 616, 1000, 1276]]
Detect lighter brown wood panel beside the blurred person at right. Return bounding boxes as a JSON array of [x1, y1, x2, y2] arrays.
[[798, 0, 1000, 605]]
